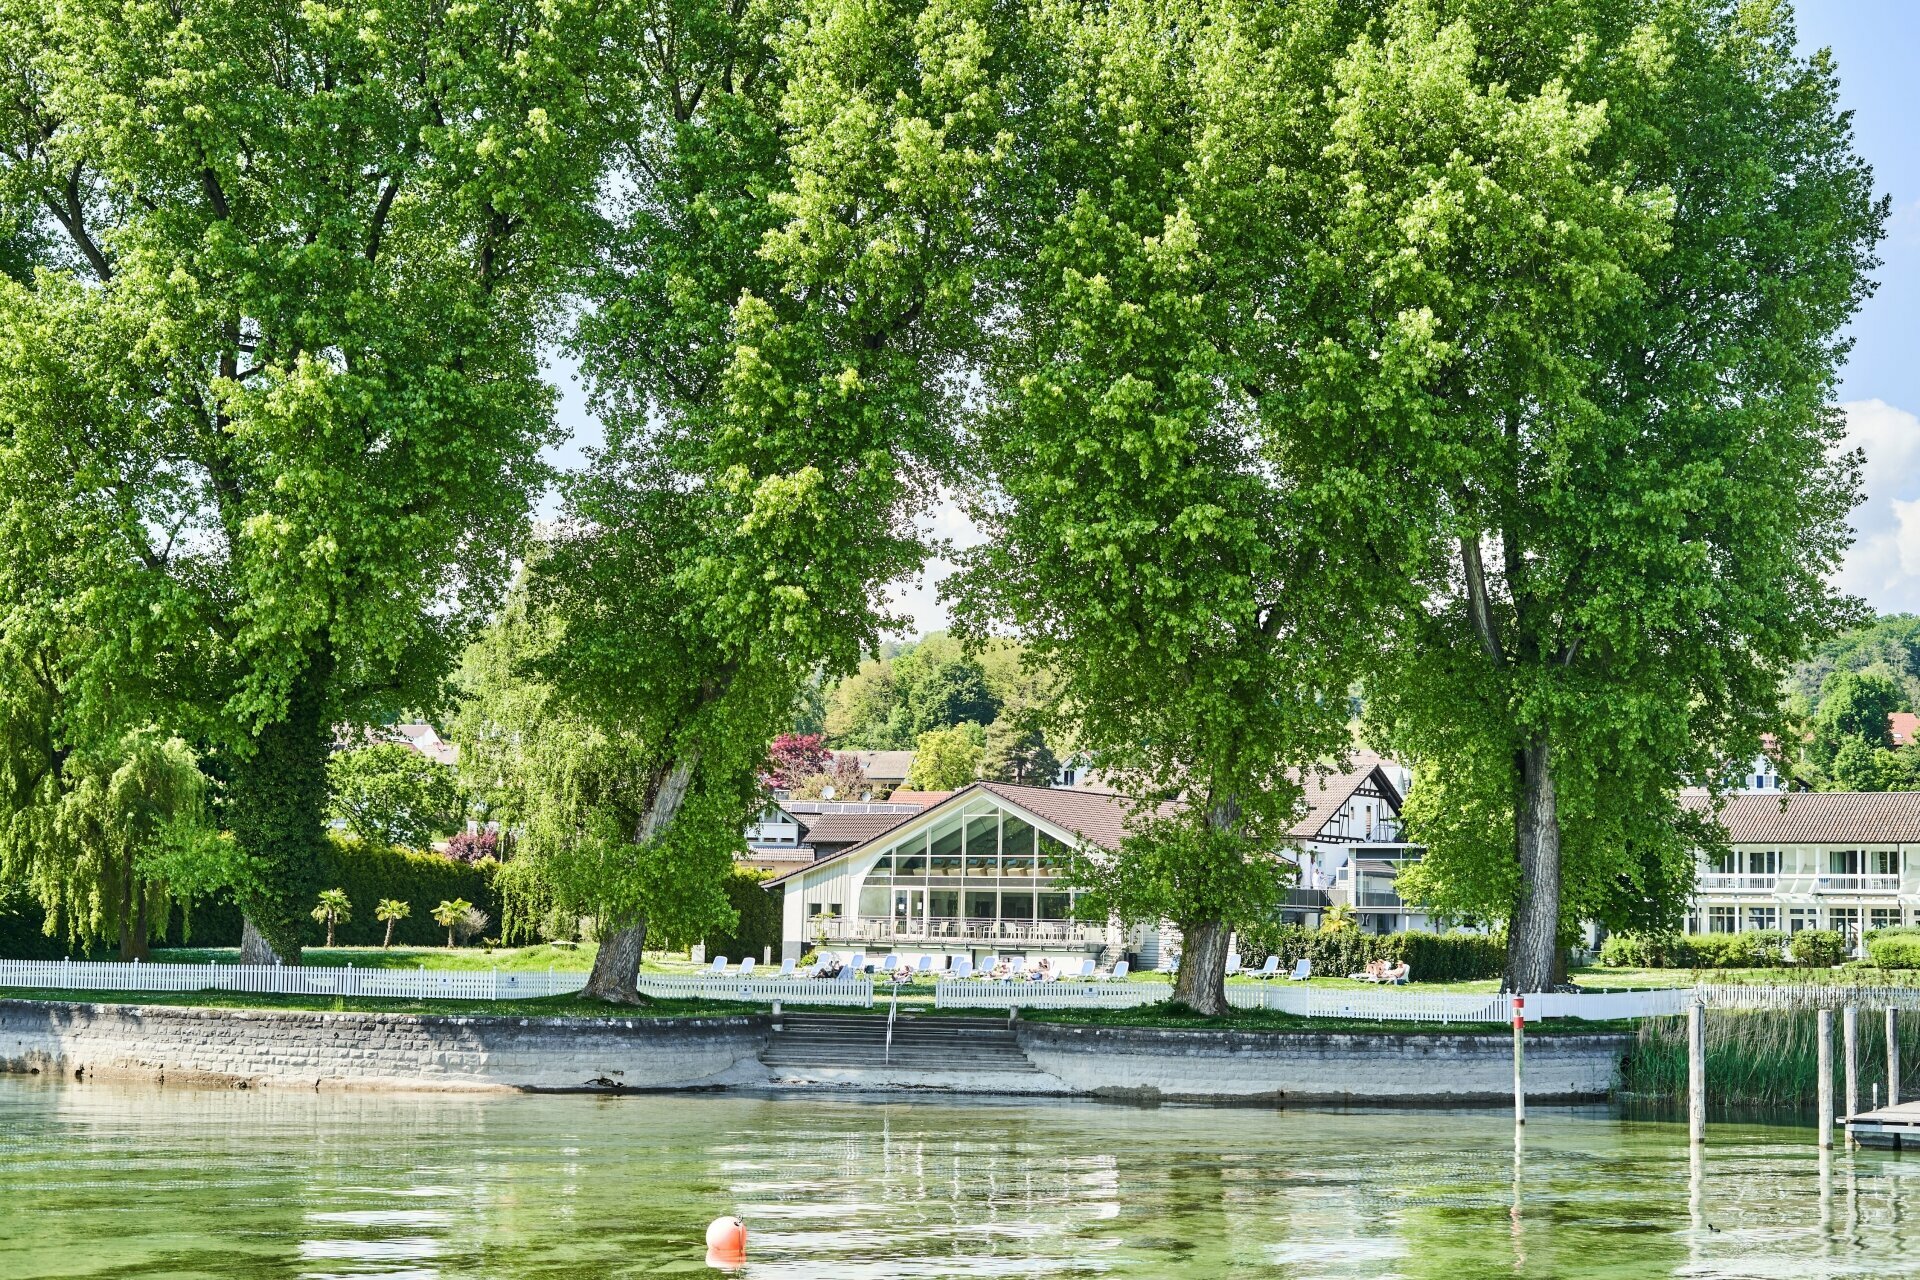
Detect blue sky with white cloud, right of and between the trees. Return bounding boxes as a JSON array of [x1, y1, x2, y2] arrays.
[[541, 0, 1920, 633]]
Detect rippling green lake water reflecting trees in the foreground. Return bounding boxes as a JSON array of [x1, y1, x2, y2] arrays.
[[0, 1077, 1920, 1280]]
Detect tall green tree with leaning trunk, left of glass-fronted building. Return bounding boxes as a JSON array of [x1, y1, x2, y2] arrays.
[[491, 0, 1000, 1002]]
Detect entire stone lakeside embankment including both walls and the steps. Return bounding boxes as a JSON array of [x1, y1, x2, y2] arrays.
[[0, 1000, 1630, 1105]]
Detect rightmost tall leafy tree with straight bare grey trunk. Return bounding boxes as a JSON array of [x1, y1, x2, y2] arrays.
[[1311, 0, 1885, 990]]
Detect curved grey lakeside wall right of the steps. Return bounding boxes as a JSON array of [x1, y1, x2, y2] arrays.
[[1018, 1021, 1630, 1105]]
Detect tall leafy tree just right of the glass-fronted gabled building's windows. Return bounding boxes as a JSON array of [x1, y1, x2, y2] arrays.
[[958, 4, 1377, 1013]]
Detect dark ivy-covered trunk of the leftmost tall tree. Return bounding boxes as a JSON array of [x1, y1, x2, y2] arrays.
[[227, 654, 334, 965]]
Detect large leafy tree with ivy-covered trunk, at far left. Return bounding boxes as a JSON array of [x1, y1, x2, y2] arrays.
[[0, 0, 620, 961]]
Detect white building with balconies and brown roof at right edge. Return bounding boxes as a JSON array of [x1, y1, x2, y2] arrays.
[[1688, 791, 1920, 946]]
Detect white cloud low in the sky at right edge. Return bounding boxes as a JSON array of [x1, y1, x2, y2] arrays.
[[1834, 399, 1920, 614]]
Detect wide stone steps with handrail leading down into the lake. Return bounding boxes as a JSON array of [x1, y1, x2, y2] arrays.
[[760, 1011, 1046, 1088]]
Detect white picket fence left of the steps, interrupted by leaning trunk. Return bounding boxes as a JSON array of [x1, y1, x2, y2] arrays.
[[0, 960, 874, 1009]]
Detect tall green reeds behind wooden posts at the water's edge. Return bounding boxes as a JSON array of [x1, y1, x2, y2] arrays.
[[1620, 1006, 1920, 1109]]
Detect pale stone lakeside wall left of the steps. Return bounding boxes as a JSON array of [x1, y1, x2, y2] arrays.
[[0, 1000, 768, 1090]]
